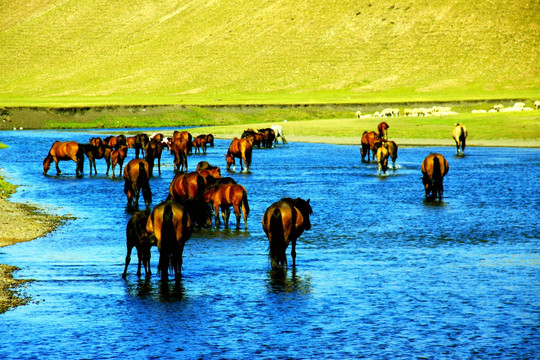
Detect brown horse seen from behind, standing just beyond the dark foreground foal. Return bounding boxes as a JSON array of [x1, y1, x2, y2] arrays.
[[124, 159, 152, 207]]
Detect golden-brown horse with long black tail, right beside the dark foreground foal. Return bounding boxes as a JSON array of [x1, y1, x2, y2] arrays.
[[146, 201, 193, 281]]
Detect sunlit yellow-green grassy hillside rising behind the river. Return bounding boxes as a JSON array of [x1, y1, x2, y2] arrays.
[[0, 0, 540, 106]]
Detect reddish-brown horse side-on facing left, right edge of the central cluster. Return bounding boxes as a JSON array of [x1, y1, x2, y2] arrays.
[[202, 184, 249, 230]]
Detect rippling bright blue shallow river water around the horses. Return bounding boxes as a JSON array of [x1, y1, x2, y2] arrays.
[[0, 130, 540, 359]]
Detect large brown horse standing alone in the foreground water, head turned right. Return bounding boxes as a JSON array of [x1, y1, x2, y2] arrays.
[[262, 198, 313, 269]]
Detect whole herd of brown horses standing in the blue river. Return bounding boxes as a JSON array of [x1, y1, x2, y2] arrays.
[[43, 122, 467, 280]]
